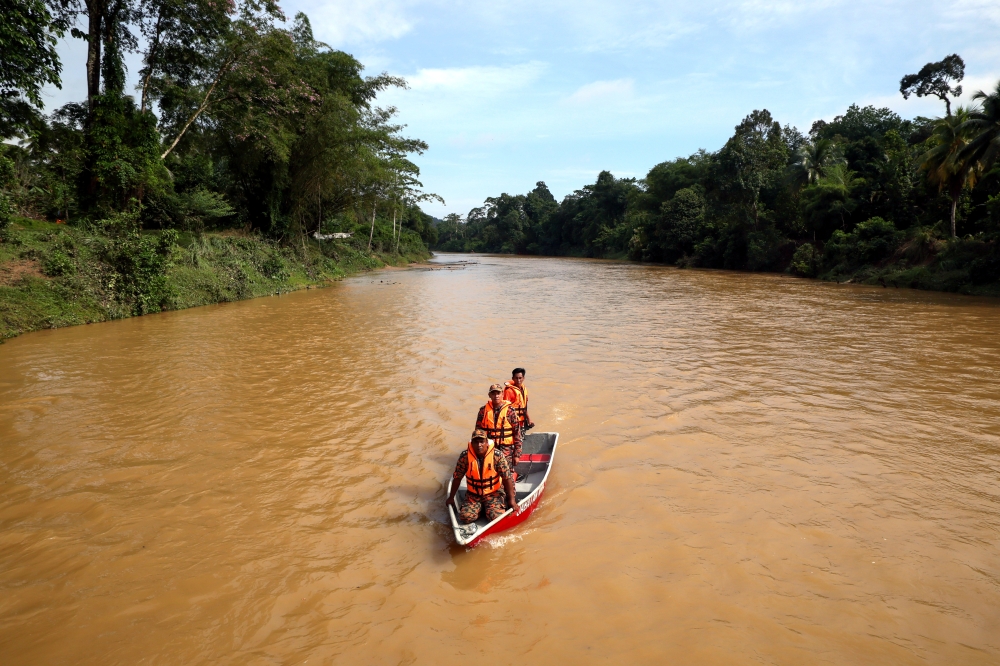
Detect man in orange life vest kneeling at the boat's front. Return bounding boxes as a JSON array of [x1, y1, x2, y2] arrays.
[[445, 428, 517, 523]]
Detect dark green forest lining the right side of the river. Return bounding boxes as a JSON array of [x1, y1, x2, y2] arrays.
[[435, 55, 1000, 293]]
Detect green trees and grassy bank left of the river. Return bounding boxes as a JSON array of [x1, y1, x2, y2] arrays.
[[0, 0, 437, 333]]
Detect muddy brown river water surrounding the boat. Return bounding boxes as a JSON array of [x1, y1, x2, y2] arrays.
[[0, 255, 1000, 665]]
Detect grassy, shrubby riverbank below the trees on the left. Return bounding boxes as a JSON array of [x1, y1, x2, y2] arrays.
[[0, 218, 430, 341]]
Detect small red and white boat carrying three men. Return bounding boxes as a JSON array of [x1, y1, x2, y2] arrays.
[[447, 432, 559, 548]]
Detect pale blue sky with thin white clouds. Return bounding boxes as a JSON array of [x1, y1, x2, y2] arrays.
[[43, 0, 1000, 216]]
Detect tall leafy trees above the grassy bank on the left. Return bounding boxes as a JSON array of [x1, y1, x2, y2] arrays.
[[0, 0, 435, 252]]
